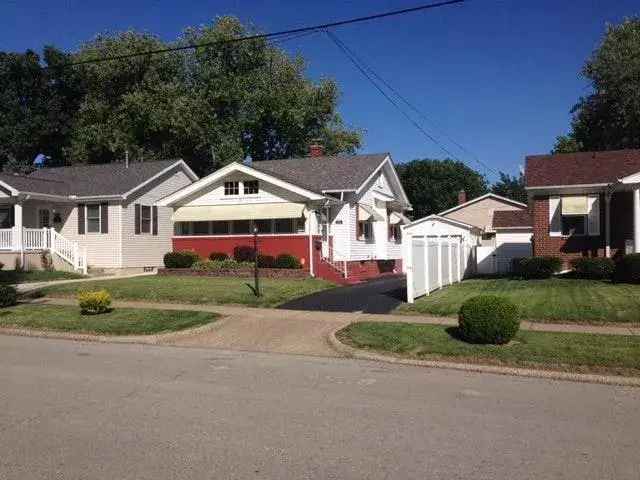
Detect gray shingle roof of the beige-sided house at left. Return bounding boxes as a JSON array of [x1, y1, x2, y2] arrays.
[[0, 160, 178, 197]]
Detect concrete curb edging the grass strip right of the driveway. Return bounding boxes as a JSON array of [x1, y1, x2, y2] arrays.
[[328, 326, 640, 387]]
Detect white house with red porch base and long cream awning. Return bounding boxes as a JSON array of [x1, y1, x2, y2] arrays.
[[159, 147, 411, 283]]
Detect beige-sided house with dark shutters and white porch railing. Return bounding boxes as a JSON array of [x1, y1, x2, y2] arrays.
[[0, 160, 198, 272]]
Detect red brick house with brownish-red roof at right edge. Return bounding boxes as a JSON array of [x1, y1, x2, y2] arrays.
[[525, 150, 640, 268]]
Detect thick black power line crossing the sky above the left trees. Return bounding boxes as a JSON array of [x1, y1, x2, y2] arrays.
[[53, 0, 465, 68]]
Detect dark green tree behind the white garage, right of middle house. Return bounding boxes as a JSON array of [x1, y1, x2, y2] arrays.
[[396, 159, 489, 218]]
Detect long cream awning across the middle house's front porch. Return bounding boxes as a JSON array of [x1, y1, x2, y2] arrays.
[[171, 203, 304, 222]]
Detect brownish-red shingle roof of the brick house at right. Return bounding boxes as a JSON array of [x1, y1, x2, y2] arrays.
[[525, 149, 640, 189]]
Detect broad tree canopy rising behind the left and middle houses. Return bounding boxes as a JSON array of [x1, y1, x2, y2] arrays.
[[0, 17, 362, 174]]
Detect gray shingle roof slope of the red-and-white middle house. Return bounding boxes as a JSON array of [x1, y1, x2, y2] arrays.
[[251, 153, 389, 193]]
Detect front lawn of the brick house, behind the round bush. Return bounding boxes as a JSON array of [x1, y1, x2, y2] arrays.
[[398, 278, 640, 324]]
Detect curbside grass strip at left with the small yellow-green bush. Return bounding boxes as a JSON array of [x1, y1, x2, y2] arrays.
[[0, 305, 217, 335]]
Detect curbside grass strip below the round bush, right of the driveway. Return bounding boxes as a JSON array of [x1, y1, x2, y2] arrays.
[[337, 322, 640, 376]]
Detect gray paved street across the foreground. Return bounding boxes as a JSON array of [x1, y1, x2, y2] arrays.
[[0, 336, 640, 480]]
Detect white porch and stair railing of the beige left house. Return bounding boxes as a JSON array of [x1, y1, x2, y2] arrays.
[[0, 227, 87, 274]]
